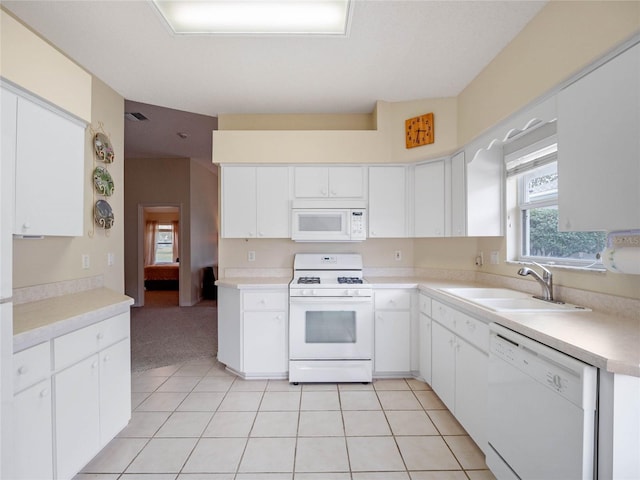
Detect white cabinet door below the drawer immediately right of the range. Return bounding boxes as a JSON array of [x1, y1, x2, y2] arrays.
[[374, 310, 411, 373]]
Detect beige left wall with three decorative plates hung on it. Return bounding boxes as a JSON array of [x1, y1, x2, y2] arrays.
[[13, 78, 124, 292]]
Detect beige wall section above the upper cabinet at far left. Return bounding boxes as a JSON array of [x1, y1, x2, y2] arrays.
[[0, 10, 93, 122]]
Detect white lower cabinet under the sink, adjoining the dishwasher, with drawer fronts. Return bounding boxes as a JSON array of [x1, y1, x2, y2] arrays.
[[431, 300, 489, 451]]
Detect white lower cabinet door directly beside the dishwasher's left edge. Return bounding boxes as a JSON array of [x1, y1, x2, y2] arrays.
[[454, 338, 489, 451]]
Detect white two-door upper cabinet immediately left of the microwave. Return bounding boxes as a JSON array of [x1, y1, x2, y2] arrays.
[[222, 166, 290, 238]]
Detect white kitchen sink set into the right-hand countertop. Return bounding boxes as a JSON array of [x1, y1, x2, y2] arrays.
[[440, 287, 591, 313]]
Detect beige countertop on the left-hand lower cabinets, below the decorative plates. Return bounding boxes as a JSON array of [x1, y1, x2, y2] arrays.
[[13, 288, 133, 352]]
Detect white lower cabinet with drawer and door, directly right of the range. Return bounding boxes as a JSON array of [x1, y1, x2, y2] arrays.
[[373, 289, 412, 376]]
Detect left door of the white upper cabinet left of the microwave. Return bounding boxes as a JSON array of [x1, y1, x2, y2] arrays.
[[222, 167, 257, 238]]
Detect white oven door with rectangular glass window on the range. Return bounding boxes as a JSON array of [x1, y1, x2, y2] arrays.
[[289, 297, 373, 360]]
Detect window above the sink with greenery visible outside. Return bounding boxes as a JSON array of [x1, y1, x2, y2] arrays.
[[505, 136, 606, 268]]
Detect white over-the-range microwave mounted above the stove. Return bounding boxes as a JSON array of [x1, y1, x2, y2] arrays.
[[291, 200, 367, 242]]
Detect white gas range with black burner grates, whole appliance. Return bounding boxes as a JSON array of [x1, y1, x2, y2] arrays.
[[289, 253, 373, 383]]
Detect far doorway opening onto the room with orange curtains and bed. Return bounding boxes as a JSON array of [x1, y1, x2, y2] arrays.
[[138, 204, 185, 307]]
